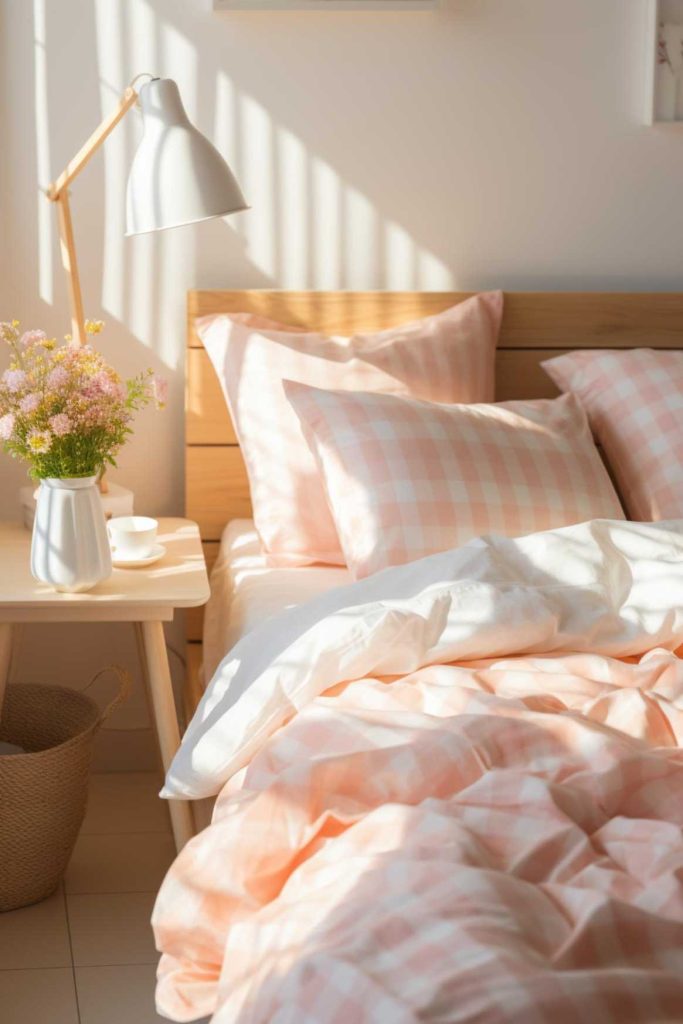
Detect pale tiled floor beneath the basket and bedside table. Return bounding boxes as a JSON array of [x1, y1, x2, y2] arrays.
[[0, 772, 192, 1024]]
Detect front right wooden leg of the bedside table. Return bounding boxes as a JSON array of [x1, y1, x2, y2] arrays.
[[140, 623, 195, 851]]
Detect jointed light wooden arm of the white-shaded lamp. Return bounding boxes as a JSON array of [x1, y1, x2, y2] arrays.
[[47, 85, 137, 345]]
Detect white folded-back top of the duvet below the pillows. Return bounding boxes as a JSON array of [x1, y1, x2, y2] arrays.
[[162, 520, 683, 799]]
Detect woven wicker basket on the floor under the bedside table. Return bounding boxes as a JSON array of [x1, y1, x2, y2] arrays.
[[0, 666, 130, 911]]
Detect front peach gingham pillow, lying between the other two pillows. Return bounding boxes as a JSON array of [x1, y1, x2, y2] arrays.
[[285, 382, 624, 579]]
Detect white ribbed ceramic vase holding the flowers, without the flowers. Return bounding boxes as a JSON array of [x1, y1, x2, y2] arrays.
[[31, 476, 112, 593]]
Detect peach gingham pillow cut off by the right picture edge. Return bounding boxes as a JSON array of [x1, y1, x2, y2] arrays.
[[542, 348, 683, 522]]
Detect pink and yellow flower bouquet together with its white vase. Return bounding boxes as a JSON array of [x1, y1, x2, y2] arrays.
[[0, 321, 166, 591]]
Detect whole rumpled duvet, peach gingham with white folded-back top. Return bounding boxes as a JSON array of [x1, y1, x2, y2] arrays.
[[153, 521, 683, 1024]]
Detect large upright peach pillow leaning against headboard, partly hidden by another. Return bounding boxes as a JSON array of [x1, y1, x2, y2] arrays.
[[197, 292, 503, 565]]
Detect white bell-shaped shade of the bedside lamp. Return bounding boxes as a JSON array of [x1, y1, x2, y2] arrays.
[[126, 78, 248, 234]]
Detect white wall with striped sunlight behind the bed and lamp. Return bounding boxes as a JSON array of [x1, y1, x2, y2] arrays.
[[0, 0, 683, 764]]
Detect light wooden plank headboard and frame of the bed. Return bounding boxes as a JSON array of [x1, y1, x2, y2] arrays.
[[184, 291, 683, 715]]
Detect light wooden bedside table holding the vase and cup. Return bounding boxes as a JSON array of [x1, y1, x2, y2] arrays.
[[0, 519, 209, 850]]
